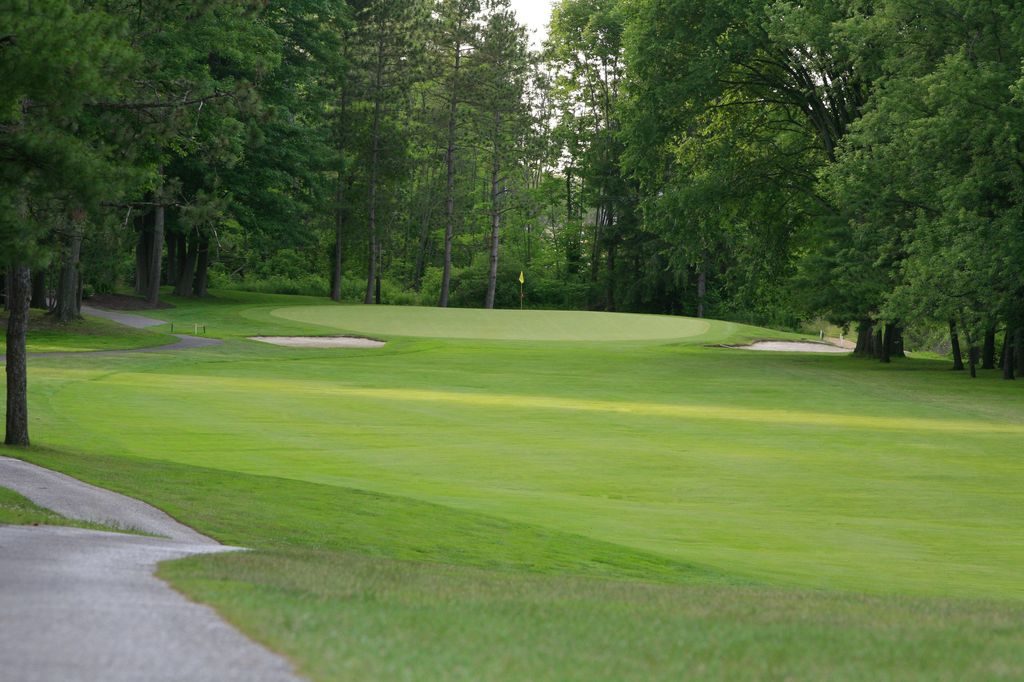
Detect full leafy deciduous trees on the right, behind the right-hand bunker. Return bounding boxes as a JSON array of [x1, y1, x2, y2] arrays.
[[625, 0, 1024, 378]]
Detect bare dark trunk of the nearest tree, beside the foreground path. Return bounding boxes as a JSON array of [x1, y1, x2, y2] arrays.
[[4, 265, 32, 445]]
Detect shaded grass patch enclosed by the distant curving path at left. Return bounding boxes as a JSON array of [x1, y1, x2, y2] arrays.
[[0, 310, 177, 355]]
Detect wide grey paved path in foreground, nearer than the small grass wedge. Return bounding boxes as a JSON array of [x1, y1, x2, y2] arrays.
[[0, 525, 298, 682]]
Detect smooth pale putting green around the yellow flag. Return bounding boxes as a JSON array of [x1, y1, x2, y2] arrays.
[[270, 305, 720, 341]]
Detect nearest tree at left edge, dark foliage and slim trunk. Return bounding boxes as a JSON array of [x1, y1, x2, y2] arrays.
[[0, 0, 131, 445]]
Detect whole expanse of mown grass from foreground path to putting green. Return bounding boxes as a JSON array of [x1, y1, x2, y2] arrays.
[[0, 292, 1024, 680]]
